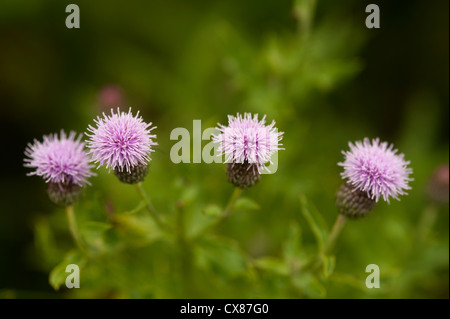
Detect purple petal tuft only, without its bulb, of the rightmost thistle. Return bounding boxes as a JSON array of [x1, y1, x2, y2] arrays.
[[338, 138, 412, 203]]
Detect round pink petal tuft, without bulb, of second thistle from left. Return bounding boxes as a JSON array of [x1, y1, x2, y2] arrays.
[[86, 108, 157, 172]]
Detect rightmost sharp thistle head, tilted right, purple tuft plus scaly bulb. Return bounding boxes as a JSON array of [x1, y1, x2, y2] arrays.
[[337, 138, 412, 217]]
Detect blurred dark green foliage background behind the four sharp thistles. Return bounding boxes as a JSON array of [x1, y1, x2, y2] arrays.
[[0, 0, 449, 298]]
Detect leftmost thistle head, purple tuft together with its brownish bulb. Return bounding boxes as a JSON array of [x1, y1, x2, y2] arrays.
[[24, 130, 95, 206]]
